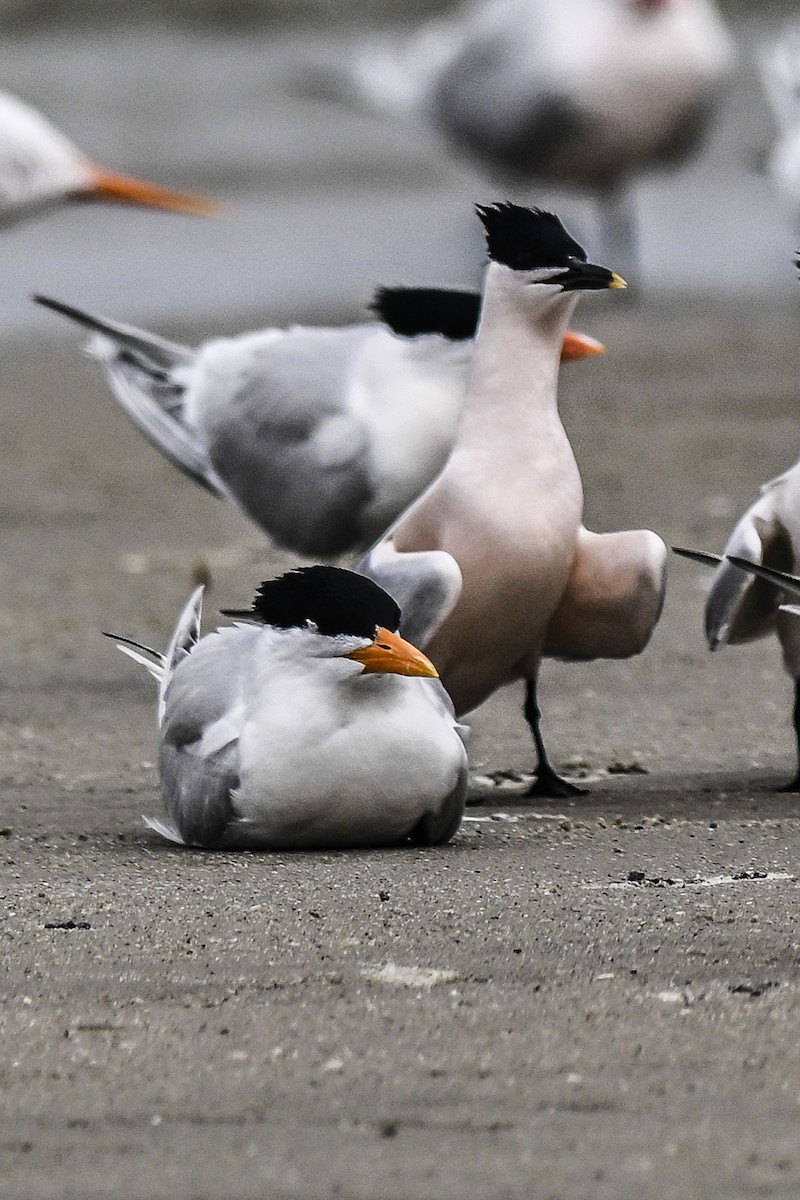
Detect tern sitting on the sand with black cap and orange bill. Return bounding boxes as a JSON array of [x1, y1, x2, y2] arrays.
[[108, 566, 468, 850]]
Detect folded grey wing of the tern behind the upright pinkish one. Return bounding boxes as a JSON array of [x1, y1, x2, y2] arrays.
[[193, 324, 383, 557]]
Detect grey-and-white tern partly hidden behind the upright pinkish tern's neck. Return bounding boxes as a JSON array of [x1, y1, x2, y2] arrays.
[[36, 288, 603, 557]]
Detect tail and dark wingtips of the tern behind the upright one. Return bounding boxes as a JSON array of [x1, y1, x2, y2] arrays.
[[34, 295, 230, 499]]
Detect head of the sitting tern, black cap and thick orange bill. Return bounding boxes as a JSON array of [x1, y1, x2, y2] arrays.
[[222, 566, 438, 679]]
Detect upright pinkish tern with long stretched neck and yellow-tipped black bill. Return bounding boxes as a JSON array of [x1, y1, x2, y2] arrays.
[[357, 204, 667, 796]]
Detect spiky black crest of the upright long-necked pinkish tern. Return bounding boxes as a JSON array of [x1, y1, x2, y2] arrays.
[[476, 202, 587, 271]]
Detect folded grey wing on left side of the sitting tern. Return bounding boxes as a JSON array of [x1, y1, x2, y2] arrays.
[[158, 625, 259, 846]]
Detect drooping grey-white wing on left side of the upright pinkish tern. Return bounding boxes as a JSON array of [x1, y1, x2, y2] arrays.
[[355, 536, 462, 649]]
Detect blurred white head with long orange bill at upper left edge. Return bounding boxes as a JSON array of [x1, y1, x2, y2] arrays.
[[0, 92, 218, 226]]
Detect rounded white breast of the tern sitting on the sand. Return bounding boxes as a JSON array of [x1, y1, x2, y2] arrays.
[[234, 659, 465, 847]]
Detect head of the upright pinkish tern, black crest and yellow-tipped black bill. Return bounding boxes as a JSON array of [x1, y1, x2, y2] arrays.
[[476, 202, 627, 292]]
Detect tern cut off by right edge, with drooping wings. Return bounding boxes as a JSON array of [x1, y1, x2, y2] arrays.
[[674, 453, 800, 792]]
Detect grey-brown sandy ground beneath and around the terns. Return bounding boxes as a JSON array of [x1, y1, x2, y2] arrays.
[[0, 295, 800, 1200]]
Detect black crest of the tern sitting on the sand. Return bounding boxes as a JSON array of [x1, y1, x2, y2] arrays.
[[222, 566, 401, 637]]
